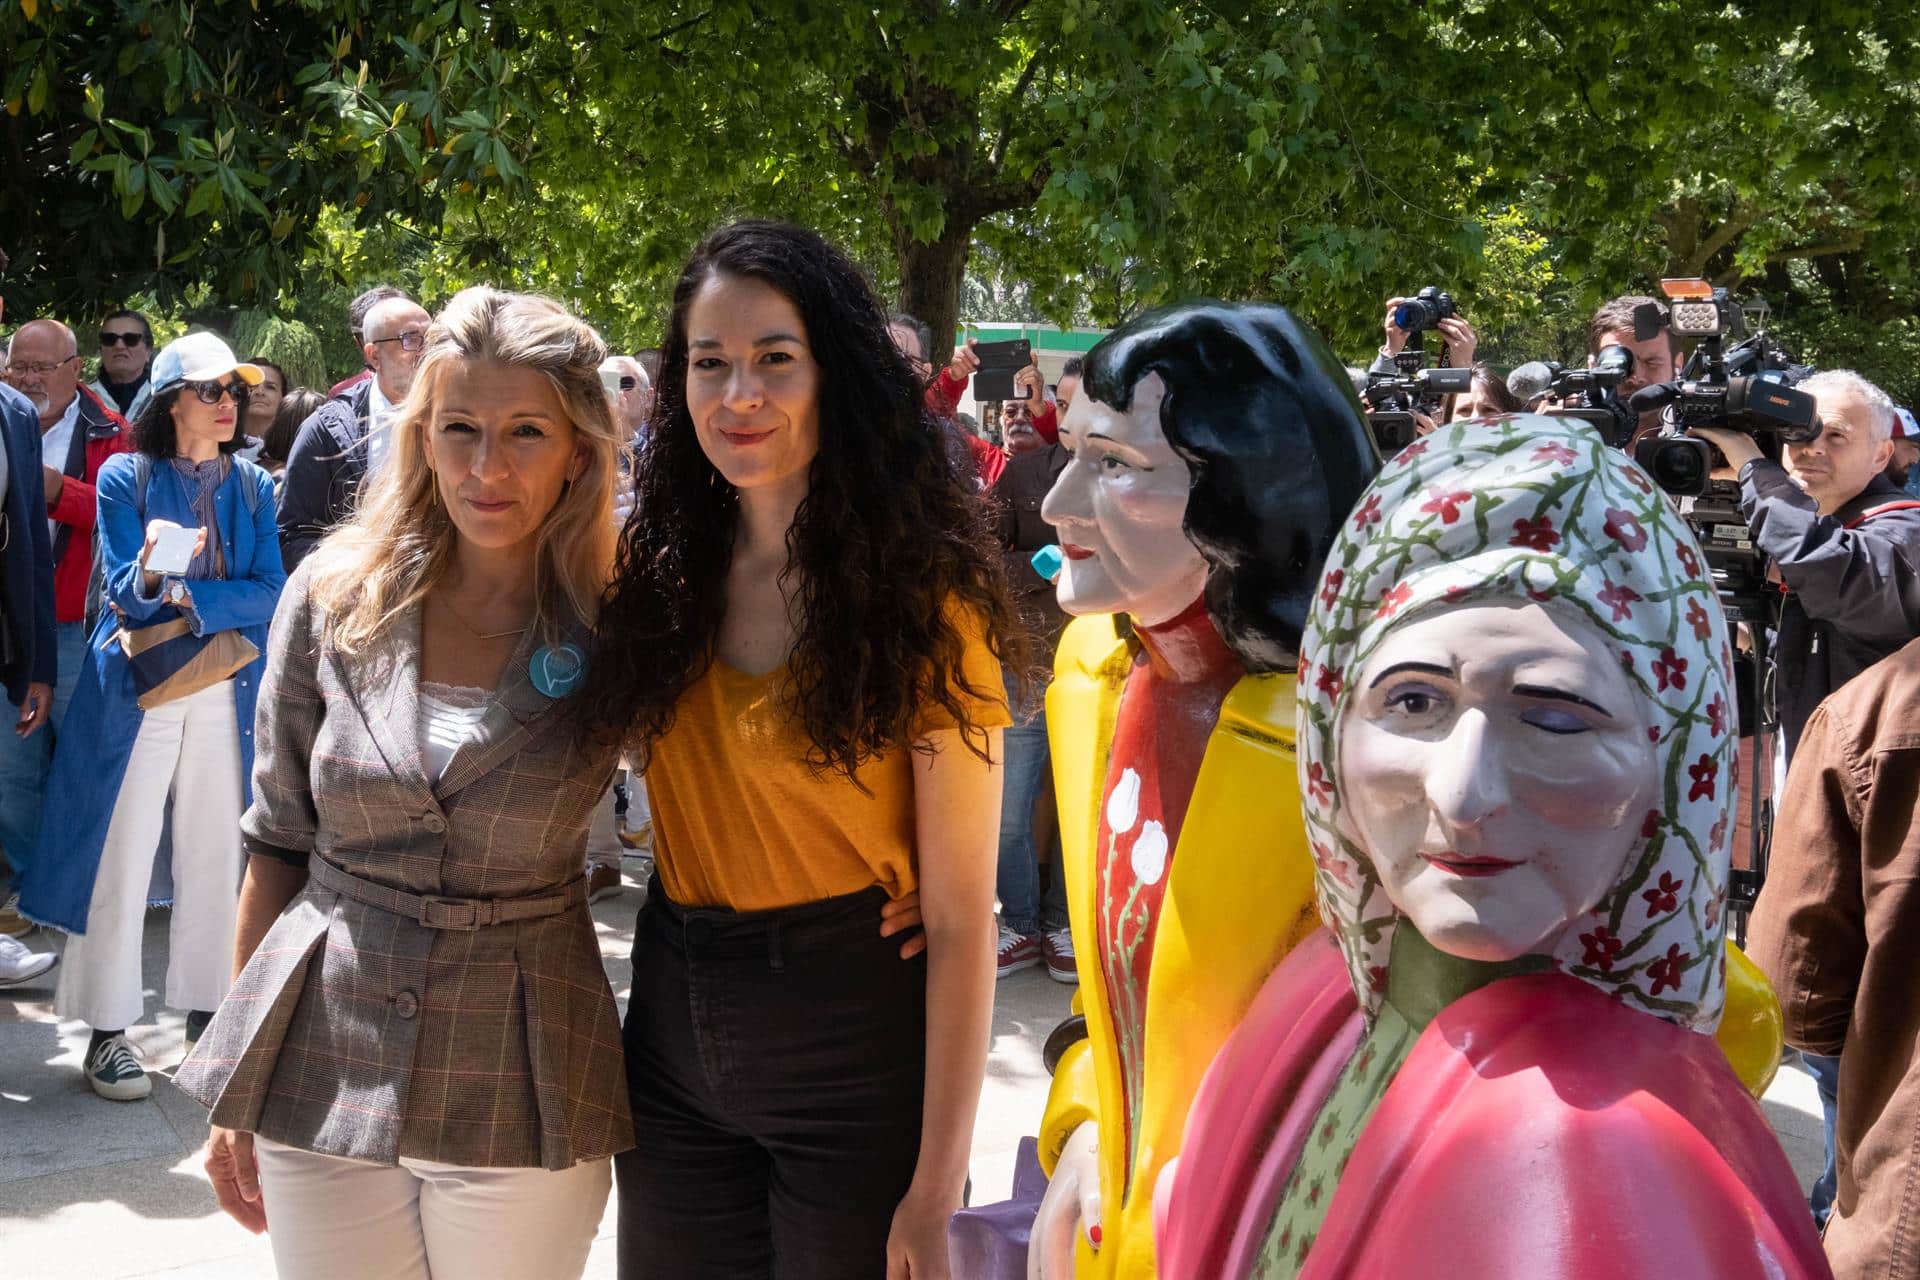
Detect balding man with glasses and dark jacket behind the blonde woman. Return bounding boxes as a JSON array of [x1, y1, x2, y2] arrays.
[[280, 296, 432, 570]]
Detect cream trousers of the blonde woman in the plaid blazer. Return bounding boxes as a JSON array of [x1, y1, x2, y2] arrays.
[[253, 1136, 612, 1280]]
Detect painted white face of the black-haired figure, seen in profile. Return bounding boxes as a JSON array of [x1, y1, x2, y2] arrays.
[[1041, 374, 1208, 626]]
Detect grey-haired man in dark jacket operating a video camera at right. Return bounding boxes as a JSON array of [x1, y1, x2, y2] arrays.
[[1692, 370, 1920, 758]]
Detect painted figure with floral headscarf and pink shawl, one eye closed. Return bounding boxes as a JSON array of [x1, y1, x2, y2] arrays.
[[1152, 416, 1830, 1280]]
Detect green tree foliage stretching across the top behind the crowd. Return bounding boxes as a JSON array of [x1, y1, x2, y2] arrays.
[[0, 0, 1920, 390]]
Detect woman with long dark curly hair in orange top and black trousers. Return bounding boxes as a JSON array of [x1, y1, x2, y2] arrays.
[[586, 223, 1027, 1280]]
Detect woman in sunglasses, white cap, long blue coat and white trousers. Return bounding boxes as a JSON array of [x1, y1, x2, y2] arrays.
[[21, 334, 286, 1102]]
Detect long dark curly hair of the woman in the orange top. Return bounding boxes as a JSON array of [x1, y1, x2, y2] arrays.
[[582, 221, 1033, 779]]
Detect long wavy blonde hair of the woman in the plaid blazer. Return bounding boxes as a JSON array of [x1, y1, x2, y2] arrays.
[[309, 286, 624, 654]]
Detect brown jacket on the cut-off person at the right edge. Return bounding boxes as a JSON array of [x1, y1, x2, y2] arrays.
[[1747, 641, 1920, 1280]]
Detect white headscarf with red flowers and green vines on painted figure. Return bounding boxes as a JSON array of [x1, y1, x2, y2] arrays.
[[1298, 415, 1738, 1032]]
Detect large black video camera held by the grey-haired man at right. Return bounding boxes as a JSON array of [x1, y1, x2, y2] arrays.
[[1628, 280, 1820, 497]]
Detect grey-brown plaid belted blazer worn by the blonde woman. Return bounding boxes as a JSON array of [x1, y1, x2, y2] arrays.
[[175, 564, 634, 1169]]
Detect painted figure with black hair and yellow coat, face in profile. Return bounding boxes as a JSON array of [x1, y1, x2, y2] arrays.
[[952, 303, 1379, 1280]]
